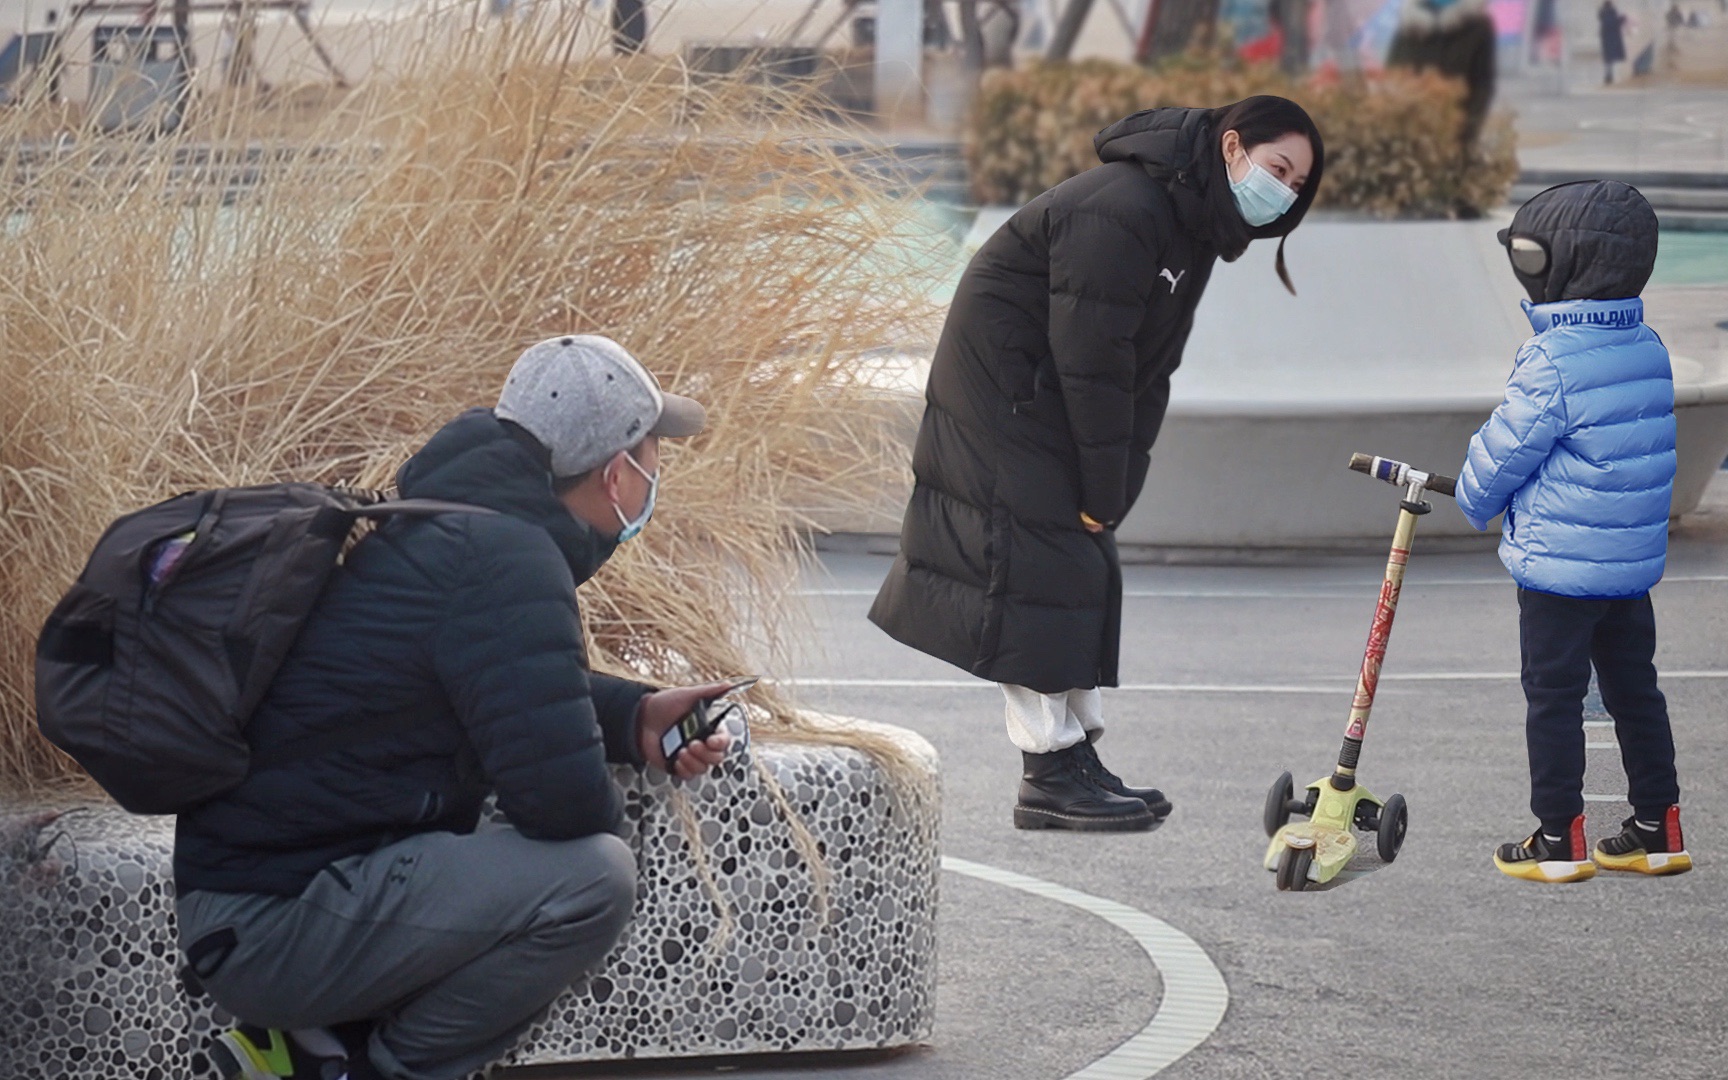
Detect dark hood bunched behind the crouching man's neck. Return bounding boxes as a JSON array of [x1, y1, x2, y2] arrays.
[[396, 410, 619, 584]]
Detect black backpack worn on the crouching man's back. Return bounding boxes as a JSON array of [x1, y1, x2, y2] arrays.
[[36, 484, 492, 814]]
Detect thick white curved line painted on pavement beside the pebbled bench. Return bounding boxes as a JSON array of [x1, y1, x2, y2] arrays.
[[942, 855, 1230, 1080]]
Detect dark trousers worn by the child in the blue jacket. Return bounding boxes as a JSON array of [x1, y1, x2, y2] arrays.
[[1517, 589, 1680, 836]]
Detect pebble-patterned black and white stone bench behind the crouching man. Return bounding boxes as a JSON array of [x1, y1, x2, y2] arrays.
[[0, 721, 938, 1080]]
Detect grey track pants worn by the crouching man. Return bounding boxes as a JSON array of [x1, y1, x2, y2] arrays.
[[176, 826, 636, 1080]]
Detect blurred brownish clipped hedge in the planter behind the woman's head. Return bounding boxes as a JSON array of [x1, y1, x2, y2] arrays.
[[966, 55, 1517, 218]]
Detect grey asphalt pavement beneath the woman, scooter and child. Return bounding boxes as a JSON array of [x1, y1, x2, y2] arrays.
[[525, 473, 1728, 1080]]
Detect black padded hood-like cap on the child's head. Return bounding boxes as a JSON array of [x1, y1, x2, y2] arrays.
[[1502, 180, 1657, 304]]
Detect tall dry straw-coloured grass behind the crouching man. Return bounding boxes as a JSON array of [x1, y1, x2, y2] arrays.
[[0, 5, 926, 790]]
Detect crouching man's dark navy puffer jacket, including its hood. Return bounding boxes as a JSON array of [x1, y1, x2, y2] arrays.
[[175, 410, 648, 895]]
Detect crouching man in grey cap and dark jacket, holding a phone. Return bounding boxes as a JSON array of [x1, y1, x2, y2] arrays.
[[175, 337, 726, 1080]]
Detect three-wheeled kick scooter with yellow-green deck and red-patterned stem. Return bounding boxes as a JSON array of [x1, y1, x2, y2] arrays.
[[1263, 454, 1455, 892]]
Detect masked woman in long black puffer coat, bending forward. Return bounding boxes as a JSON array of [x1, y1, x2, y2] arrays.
[[869, 97, 1324, 831]]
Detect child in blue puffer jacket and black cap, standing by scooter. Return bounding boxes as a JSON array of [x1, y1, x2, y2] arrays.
[[1458, 180, 1692, 881]]
